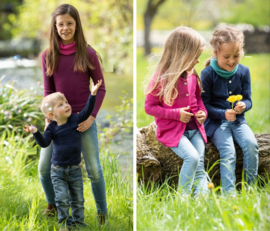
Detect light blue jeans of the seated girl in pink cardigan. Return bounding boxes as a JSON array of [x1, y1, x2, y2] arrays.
[[171, 130, 208, 196]]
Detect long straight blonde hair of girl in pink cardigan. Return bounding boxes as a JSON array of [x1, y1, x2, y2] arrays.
[[145, 26, 204, 106]]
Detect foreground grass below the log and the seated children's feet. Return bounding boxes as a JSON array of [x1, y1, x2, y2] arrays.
[[137, 180, 270, 231]]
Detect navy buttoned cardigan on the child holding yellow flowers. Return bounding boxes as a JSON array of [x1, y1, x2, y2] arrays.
[[201, 64, 252, 137]]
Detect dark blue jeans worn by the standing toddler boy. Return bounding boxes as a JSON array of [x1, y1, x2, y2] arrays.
[[51, 164, 84, 229]]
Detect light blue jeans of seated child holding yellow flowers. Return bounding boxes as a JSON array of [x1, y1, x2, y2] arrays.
[[212, 120, 259, 195]]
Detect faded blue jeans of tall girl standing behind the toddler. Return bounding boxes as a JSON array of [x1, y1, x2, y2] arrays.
[[38, 121, 107, 215]]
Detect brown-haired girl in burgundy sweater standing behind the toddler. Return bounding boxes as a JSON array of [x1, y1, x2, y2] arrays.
[[38, 4, 107, 227]]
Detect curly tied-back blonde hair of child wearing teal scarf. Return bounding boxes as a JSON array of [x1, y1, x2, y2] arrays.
[[205, 26, 244, 67]]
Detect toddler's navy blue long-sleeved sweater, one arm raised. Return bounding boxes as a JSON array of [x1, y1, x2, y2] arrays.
[[33, 95, 96, 166]]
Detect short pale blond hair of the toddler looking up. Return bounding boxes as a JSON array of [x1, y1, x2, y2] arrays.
[[40, 92, 66, 116]]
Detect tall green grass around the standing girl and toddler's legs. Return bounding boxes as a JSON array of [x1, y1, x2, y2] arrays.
[[0, 131, 133, 231]]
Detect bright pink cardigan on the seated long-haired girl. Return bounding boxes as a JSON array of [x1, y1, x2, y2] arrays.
[[145, 75, 207, 147]]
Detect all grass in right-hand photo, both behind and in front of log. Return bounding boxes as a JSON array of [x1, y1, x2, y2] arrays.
[[137, 48, 270, 231]]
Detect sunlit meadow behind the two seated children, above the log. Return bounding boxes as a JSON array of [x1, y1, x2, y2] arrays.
[[137, 48, 270, 133]]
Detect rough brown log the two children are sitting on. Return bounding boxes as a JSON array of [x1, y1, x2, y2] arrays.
[[137, 122, 270, 187]]
